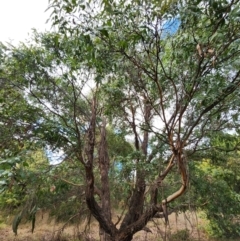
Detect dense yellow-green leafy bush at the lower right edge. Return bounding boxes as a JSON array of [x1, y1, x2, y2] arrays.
[[191, 135, 240, 237]]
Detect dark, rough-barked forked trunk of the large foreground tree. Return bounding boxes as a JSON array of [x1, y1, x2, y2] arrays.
[[81, 97, 187, 241]]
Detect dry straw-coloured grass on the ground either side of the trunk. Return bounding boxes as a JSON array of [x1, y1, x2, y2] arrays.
[[0, 211, 214, 241]]
